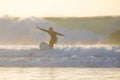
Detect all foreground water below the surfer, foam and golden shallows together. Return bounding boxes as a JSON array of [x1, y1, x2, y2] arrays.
[[0, 45, 120, 80]]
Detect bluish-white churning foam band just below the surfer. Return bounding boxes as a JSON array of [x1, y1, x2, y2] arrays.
[[0, 45, 120, 67]]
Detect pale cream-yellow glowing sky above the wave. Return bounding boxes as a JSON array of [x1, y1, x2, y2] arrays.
[[0, 0, 120, 17]]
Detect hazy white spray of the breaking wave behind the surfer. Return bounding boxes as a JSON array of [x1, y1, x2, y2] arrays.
[[0, 16, 119, 45]]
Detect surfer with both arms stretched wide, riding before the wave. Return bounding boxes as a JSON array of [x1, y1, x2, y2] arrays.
[[36, 26, 64, 47]]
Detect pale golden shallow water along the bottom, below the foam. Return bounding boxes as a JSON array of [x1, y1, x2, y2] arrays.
[[0, 67, 120, 80]]
